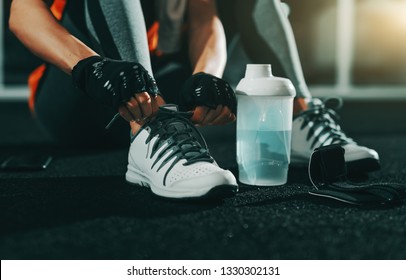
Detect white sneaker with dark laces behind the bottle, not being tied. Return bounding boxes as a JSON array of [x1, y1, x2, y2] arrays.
[[291, 99, 380, 174]]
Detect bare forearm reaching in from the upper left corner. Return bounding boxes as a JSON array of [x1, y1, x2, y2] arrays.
[[9, 0, 97, 74]]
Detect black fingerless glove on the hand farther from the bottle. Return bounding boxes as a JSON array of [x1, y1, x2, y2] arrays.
[[72, 56, 159, 109]]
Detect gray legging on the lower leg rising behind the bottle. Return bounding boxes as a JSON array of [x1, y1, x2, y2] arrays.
[[229, 0, 311, 99]]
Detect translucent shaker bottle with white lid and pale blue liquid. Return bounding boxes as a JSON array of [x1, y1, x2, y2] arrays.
[[236, 64, 296, 186]]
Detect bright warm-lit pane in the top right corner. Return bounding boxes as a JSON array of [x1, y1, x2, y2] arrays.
[[354, 0, 406, 82]]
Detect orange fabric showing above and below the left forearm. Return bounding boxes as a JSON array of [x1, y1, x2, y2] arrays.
[[28, 0, 67, 112]]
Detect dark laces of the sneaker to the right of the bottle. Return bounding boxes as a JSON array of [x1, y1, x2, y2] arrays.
[[300, 99, 352, 149]]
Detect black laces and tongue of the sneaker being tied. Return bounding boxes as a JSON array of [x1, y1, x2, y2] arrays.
[[145, 108, 214, 185]]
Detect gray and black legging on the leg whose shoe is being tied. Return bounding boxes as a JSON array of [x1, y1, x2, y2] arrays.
[[35, 0, 191, 147]]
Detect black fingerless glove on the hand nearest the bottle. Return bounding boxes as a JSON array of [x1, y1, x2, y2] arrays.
[[179, 72, 237, 114]]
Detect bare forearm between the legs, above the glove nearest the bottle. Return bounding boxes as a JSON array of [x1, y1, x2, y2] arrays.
[[189, 1, 227, 77]]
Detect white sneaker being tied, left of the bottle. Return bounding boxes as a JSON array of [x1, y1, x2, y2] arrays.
[[126, 105, 238, 198]]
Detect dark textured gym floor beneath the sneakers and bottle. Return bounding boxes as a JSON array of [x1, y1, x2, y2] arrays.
[[0, 103, 406, 259]]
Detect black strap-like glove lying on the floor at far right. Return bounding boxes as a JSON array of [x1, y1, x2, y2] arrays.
[[308, 144, 406, 206]]
